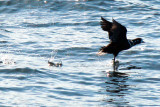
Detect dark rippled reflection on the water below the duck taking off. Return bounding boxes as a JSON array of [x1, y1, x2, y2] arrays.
[[103, 61, 138, 106]]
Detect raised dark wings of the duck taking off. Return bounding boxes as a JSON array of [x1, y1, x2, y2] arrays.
[[100, 17, 127, 42]]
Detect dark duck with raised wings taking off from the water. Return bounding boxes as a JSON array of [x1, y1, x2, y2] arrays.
[[97, 16, 144, 63]]
